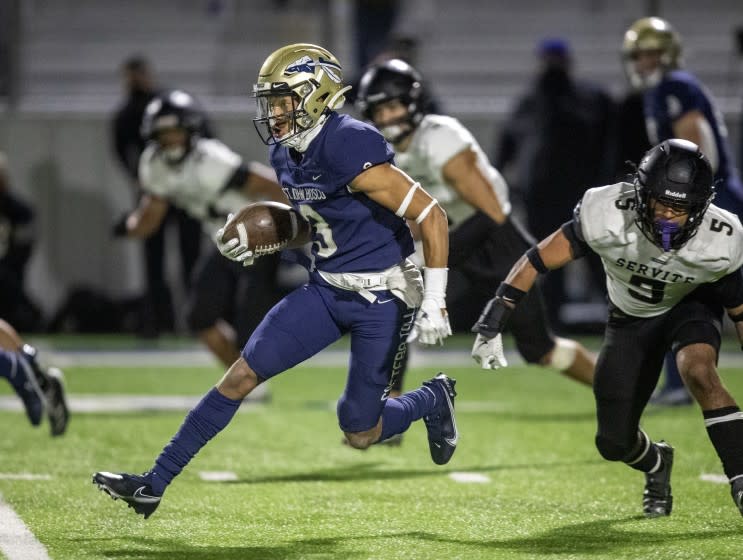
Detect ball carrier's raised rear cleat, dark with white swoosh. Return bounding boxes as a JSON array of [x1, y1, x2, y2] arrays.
[[423, 373, 459, 465]]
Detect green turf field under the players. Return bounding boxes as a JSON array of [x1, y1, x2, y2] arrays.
[[0, 340, 743, 560]]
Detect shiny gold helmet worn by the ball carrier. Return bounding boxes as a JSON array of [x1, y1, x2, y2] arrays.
[[253, 43, 351, 147]]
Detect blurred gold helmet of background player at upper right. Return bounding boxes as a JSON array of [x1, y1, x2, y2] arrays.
[[622, 17, 682, 88]]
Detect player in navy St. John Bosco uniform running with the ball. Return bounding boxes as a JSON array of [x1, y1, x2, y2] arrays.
[[93, 44, 458, 517]]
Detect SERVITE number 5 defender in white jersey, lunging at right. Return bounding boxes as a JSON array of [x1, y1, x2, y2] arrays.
[[473, 139, 743, 517]]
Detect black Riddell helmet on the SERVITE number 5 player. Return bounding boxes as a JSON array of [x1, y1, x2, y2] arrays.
[[634, 138, 715, 251]]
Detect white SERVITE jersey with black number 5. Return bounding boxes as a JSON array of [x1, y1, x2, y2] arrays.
[[578, 183, 743, 317]]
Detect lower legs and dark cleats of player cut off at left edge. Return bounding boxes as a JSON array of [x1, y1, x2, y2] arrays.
[[0, 319, 70, 436]]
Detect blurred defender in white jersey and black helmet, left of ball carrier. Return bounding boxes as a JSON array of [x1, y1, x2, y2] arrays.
[[119, 90, 286, 366]]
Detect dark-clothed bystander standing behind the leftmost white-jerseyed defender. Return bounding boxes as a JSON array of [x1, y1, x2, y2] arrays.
[[112, 56, 203, 336]]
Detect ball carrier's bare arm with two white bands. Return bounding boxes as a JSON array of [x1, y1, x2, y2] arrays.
[[351, 163, 449, 268]]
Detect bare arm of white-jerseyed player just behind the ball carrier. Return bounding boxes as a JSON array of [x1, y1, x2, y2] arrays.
[[442, 148, 506, 224]]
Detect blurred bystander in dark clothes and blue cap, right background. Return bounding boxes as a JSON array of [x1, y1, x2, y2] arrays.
[[493, 38, 614, 327]]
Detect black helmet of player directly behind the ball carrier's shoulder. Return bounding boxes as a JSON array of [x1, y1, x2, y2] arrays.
[[356, 58, 429, 144]]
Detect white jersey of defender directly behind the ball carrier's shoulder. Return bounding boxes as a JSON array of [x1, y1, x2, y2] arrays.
[[395, 115, 511, 229]]
